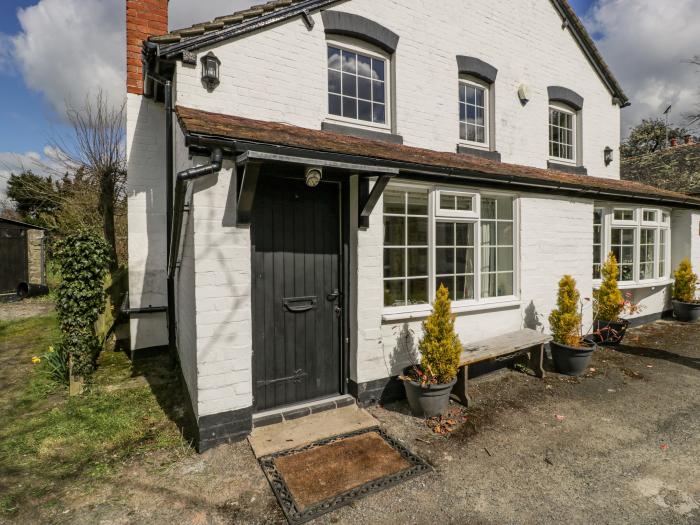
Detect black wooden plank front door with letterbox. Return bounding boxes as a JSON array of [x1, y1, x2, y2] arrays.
[[251, 173, 342, 411]]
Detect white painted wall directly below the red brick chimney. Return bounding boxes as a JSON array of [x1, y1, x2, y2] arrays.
[[126, 94, 168, 350]]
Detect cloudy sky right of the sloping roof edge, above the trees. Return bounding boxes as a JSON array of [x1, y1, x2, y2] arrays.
[[585, 0, 700, 136]]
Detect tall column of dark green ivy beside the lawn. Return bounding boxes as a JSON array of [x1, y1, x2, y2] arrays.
[[55, 231, 111, 376]]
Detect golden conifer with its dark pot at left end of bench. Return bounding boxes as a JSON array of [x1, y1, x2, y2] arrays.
[[401, 285, 462, 417]]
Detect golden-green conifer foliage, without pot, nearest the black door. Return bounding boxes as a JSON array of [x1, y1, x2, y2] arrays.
[[418, 285, 462, 384]]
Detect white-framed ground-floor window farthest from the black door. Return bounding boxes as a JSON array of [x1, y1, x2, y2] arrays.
[[593, 205, 670, 287]]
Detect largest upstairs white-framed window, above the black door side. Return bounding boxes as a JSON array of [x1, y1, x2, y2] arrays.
[[327, 41, 390, 128]]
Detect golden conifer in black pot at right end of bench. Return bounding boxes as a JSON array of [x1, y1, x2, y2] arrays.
[[549, 275, 596, 376]]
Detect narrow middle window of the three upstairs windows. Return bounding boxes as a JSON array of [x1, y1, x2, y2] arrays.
[[459, 79, 489, 147]]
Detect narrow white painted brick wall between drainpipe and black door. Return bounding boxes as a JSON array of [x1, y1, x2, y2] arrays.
[[190, 162, 253, 417]]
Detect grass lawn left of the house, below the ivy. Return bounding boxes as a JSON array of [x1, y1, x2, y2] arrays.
[[0, 315, 192, 518]]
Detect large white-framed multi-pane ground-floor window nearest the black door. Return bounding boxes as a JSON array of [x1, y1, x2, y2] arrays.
[[384, 183, 517, 313]]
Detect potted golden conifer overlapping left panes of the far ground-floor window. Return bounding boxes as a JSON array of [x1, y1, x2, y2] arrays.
[[593, 252, 642, 346]]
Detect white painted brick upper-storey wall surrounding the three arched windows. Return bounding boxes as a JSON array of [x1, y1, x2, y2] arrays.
[[177, 0, 620, 178]]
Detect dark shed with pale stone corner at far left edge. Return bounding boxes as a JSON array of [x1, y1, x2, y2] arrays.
[[0, 217, 46, 293]]
